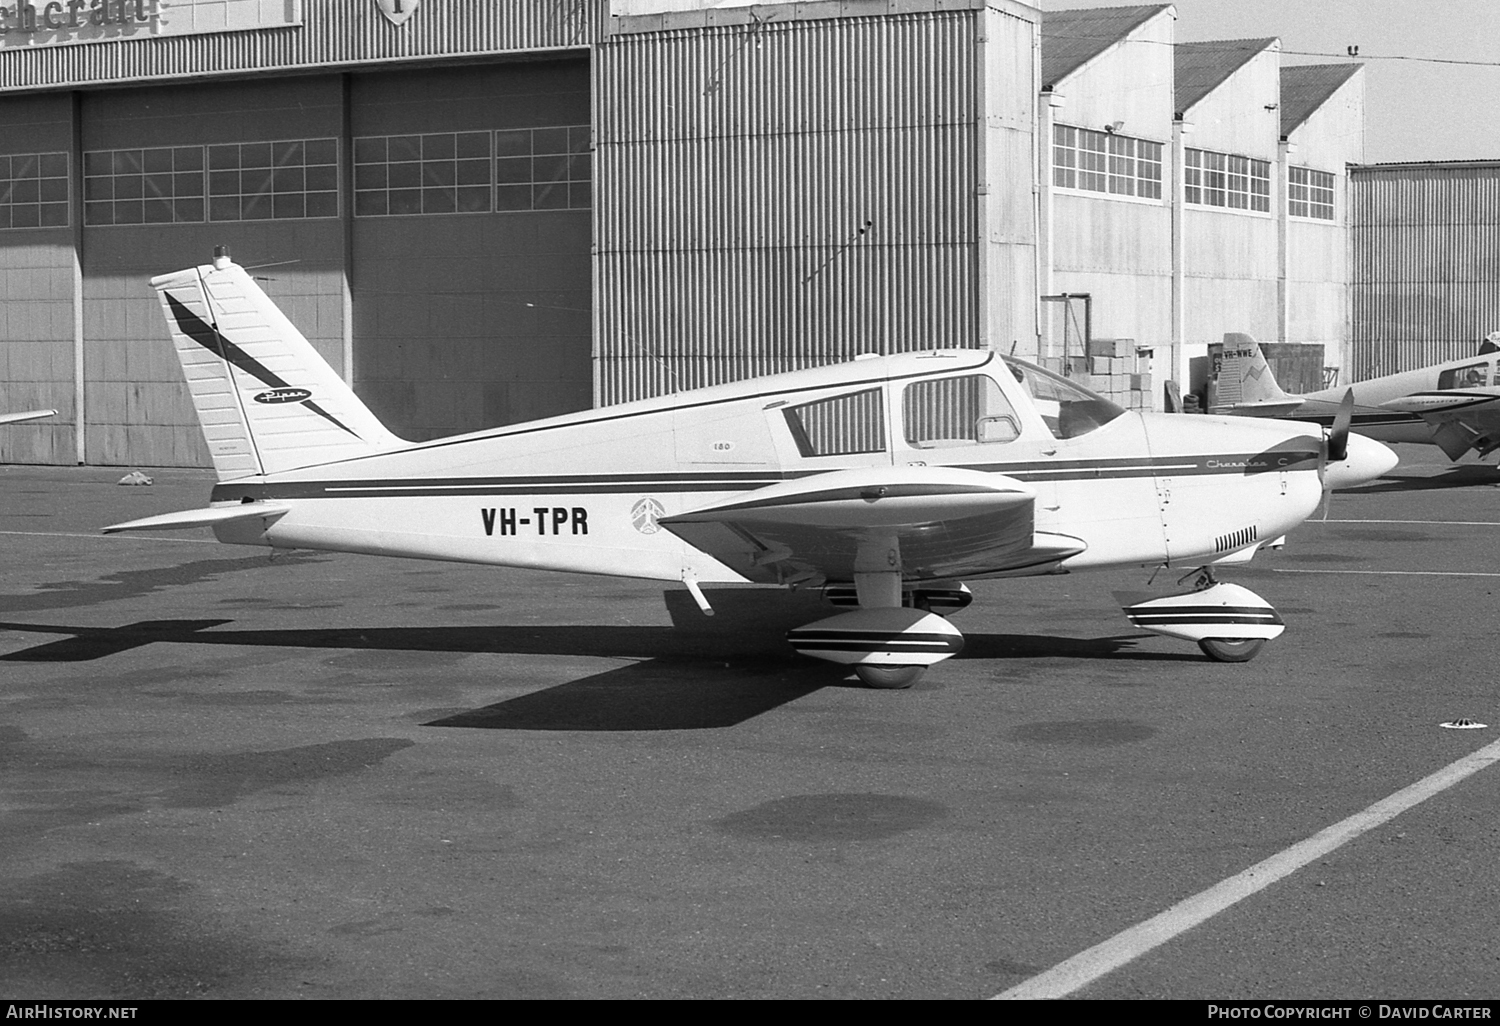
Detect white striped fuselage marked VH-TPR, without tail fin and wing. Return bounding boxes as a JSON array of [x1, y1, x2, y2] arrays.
[[213, 351, 1362, 582]]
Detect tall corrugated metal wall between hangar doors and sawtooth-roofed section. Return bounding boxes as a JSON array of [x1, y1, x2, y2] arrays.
[[596, 11, 984, 404]]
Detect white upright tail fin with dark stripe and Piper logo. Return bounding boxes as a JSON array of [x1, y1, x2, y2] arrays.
[[152, 257, 408, 482]]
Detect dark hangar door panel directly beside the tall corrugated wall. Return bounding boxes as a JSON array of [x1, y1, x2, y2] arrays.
[[350, 59, 593, 440]]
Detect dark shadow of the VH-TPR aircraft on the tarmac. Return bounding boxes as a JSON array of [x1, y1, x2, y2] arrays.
[[0, 590, 1202, 731]]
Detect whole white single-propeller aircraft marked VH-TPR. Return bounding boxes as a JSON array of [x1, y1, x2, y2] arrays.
[[105, 257, 1397, 687]]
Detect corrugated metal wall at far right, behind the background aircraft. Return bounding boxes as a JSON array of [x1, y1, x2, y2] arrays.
[[1350, 164, 1500, 381]]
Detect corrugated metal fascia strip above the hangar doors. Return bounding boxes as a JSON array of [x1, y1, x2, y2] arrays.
[[0, 0, 609, 90]]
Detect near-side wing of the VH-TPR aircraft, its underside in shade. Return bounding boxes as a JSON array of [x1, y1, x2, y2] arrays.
[[660, 467, 1086, 584]]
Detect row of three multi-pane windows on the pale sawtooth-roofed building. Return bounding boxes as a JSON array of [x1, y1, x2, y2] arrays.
[[1052, 125, 1334, 221]]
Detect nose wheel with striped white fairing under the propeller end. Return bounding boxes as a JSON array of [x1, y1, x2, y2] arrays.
[[1116, 567, 1286, 663]]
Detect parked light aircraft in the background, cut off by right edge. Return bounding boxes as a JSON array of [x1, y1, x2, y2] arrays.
[[1211, 332, 1500, 461]]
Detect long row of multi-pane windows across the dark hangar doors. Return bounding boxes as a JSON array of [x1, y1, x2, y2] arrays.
[[0, 125, 593, 228]]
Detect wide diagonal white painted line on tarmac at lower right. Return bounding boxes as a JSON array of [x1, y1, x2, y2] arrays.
[[992, 741, 1500, 1001]]
